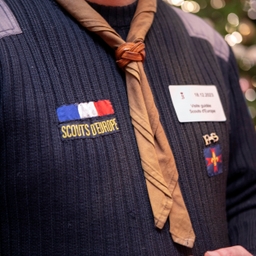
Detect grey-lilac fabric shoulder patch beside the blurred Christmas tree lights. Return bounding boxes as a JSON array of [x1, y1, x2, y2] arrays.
[[173, 8, 230, 61]]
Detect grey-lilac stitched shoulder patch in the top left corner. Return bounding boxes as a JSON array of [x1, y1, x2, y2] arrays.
[[0, 0, 22, 39]]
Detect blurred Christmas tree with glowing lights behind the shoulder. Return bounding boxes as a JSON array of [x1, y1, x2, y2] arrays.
[[165, 0, 256, 127]]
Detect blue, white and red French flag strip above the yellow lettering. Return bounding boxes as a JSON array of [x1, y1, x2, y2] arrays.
[[57, 100, 114, 122]]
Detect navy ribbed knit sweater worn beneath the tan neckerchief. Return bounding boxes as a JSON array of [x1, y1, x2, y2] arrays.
[[0, 0, 256, 256]]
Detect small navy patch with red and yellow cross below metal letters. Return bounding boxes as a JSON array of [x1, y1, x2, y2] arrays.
[[204, 144, 222, 177]]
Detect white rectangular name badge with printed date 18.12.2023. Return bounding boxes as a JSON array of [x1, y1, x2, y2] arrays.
[[169, 85, 226, 123]]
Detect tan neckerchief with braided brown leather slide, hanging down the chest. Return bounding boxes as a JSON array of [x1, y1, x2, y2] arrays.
[[56, 0, 195, 248]]
